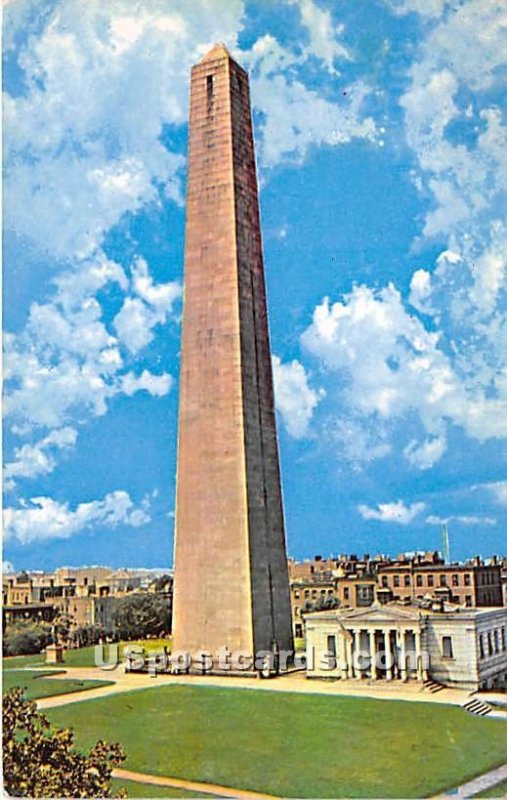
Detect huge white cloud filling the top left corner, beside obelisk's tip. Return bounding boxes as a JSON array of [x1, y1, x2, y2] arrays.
[[4, 0, 243, 258]]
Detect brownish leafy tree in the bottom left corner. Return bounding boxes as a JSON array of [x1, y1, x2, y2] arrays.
[[3, 687, 125, 797]]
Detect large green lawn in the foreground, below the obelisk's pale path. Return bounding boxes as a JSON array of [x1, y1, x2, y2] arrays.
[[44, 686, 507, 798]]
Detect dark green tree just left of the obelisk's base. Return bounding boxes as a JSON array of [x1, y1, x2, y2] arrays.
[[114, 593, 171, 639]]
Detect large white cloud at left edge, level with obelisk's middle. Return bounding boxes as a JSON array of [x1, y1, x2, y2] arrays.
[[4, 256, 177, 432]]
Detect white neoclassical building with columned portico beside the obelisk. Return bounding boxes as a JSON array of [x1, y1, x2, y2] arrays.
[[305, 603, 507, 690]]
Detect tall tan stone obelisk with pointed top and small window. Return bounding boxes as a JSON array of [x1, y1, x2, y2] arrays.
[[173, 44, 292, 671]]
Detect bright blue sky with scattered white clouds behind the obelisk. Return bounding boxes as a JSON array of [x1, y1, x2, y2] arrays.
[[4, 0, 507, 569]]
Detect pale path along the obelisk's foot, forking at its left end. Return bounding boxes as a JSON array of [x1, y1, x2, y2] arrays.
[[37, 667, 476, 719]]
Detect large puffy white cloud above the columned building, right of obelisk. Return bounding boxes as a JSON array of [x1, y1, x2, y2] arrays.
[[301, 284, 507, 469]]
